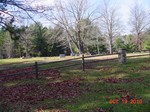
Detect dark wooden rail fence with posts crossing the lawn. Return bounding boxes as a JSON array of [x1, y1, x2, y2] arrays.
[[0, 50, 150, 79]]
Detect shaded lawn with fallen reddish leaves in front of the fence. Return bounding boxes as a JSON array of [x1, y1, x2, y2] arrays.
[[0, 56, 150, 112]]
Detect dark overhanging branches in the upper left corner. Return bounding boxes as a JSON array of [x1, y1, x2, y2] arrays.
[[0, 0, 51, 27]]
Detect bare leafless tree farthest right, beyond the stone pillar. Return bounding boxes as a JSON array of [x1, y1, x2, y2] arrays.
[[129, 3, 150, 50]]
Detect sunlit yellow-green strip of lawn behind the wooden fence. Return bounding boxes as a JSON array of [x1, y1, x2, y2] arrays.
[[0, 53, 149, 70]]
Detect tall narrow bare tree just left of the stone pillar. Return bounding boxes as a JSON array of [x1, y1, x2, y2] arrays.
[[100, 0, 122, 54]]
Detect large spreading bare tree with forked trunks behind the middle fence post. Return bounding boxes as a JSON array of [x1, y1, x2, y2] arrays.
[[48, 0, 100, 54]]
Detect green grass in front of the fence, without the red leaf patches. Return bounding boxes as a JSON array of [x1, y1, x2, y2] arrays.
[[0, 57, 150, 112]]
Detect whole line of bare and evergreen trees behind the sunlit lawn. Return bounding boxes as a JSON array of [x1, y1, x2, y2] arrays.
[[0, 0, 150, 58]]
